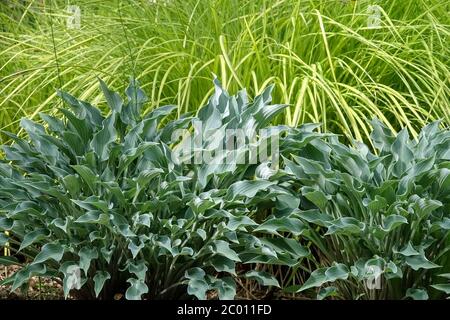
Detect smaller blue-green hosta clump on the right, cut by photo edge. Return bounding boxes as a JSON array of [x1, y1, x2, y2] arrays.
[[283, 120, 450, 299]]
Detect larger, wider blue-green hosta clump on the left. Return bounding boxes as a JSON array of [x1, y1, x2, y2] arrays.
[[0, 80, 309, 299]]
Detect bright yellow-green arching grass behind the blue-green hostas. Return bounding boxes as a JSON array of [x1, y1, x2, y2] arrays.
[[0, 0, 450, 142]]
